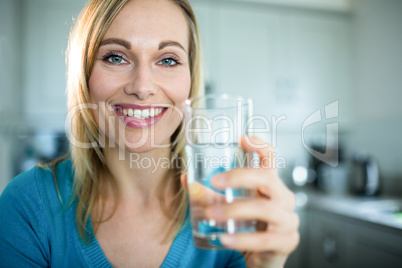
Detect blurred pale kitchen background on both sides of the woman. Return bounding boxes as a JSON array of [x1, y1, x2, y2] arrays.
[[0, 0, 402, 268]]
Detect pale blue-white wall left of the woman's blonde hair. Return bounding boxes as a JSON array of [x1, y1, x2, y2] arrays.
[[0, 0, 86, 192]]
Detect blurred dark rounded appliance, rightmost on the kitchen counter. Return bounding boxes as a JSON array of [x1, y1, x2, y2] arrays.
[[350, 154, 380, 196]]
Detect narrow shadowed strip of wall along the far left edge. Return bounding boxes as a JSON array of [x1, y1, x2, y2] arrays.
[[0, 0, 22, 193]]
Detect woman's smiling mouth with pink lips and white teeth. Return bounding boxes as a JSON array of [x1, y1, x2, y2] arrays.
[[113, 104, 168, 128]]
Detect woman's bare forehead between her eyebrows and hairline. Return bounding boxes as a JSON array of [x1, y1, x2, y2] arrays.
[[103, 0, 189, 51]]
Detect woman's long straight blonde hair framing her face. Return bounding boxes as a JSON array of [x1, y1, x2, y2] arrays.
[[66, 0, 203, 243]]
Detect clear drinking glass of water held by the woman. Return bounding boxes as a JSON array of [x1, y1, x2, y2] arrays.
[[184, 94, 256, 249]]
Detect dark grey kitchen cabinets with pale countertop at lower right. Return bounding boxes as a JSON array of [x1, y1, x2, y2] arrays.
[[285, 188, 402, 268]]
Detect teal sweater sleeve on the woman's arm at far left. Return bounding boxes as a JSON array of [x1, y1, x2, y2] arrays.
[[0, 168, 49, 267]]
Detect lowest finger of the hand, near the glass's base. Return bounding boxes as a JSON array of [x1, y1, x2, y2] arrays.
[[220, 232, 300, 254]]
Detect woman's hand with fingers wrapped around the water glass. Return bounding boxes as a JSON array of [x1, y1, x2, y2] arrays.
[[182, 137, 299, 267]]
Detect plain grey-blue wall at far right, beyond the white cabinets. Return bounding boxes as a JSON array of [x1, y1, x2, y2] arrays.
[[347, 0, 402, 185]]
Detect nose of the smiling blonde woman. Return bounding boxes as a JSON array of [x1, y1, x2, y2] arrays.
[[124, 64, 158, 100]]
